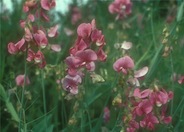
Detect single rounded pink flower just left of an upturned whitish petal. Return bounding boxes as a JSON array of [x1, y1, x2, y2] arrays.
[[113, 56, 134, 74]]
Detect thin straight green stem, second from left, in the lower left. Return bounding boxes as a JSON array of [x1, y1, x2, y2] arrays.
[[41, 69, 47, 131]]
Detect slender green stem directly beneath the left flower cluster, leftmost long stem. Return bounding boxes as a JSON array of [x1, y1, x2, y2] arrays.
[[19, 48, 28, 132]]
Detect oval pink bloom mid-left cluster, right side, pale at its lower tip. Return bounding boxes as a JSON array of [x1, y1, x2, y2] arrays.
[[33, 30, 48, 48]]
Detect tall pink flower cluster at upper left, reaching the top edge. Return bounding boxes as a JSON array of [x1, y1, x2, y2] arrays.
[[8, 0, 58, 68]]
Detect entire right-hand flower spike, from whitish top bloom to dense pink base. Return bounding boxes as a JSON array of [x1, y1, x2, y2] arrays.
[[113, 43, 173, 132]]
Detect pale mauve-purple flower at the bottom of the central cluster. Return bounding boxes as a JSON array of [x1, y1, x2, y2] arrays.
[[62, 75, 82, 94]]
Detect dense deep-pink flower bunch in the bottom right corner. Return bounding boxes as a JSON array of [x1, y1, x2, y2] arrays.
[[124, 88, 173, 132]]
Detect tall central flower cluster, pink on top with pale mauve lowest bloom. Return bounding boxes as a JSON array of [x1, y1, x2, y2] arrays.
[[63, 20, 107, 94]]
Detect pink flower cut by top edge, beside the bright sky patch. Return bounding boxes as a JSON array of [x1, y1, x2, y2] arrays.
[[40, 0, 56, 11]]
